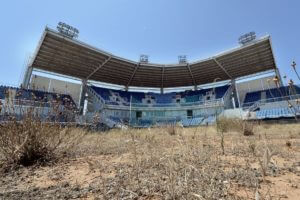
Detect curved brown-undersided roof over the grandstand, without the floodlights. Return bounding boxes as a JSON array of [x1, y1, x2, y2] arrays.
[[31, 28, 276, 88]]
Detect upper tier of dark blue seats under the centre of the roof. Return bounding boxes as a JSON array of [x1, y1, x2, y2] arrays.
[[91, 85, 229, 106]]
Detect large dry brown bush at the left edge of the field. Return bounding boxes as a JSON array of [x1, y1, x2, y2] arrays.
[[0, 106, 83, 167]]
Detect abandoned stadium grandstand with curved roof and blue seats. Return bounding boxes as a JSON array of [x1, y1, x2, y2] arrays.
[[0, 23, 300, 127]]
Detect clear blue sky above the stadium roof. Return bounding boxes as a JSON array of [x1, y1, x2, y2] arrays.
[[0, 0, 300, 84]]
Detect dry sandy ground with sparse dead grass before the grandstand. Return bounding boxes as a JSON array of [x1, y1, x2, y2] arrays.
[[0, 124, 300, 200]]
